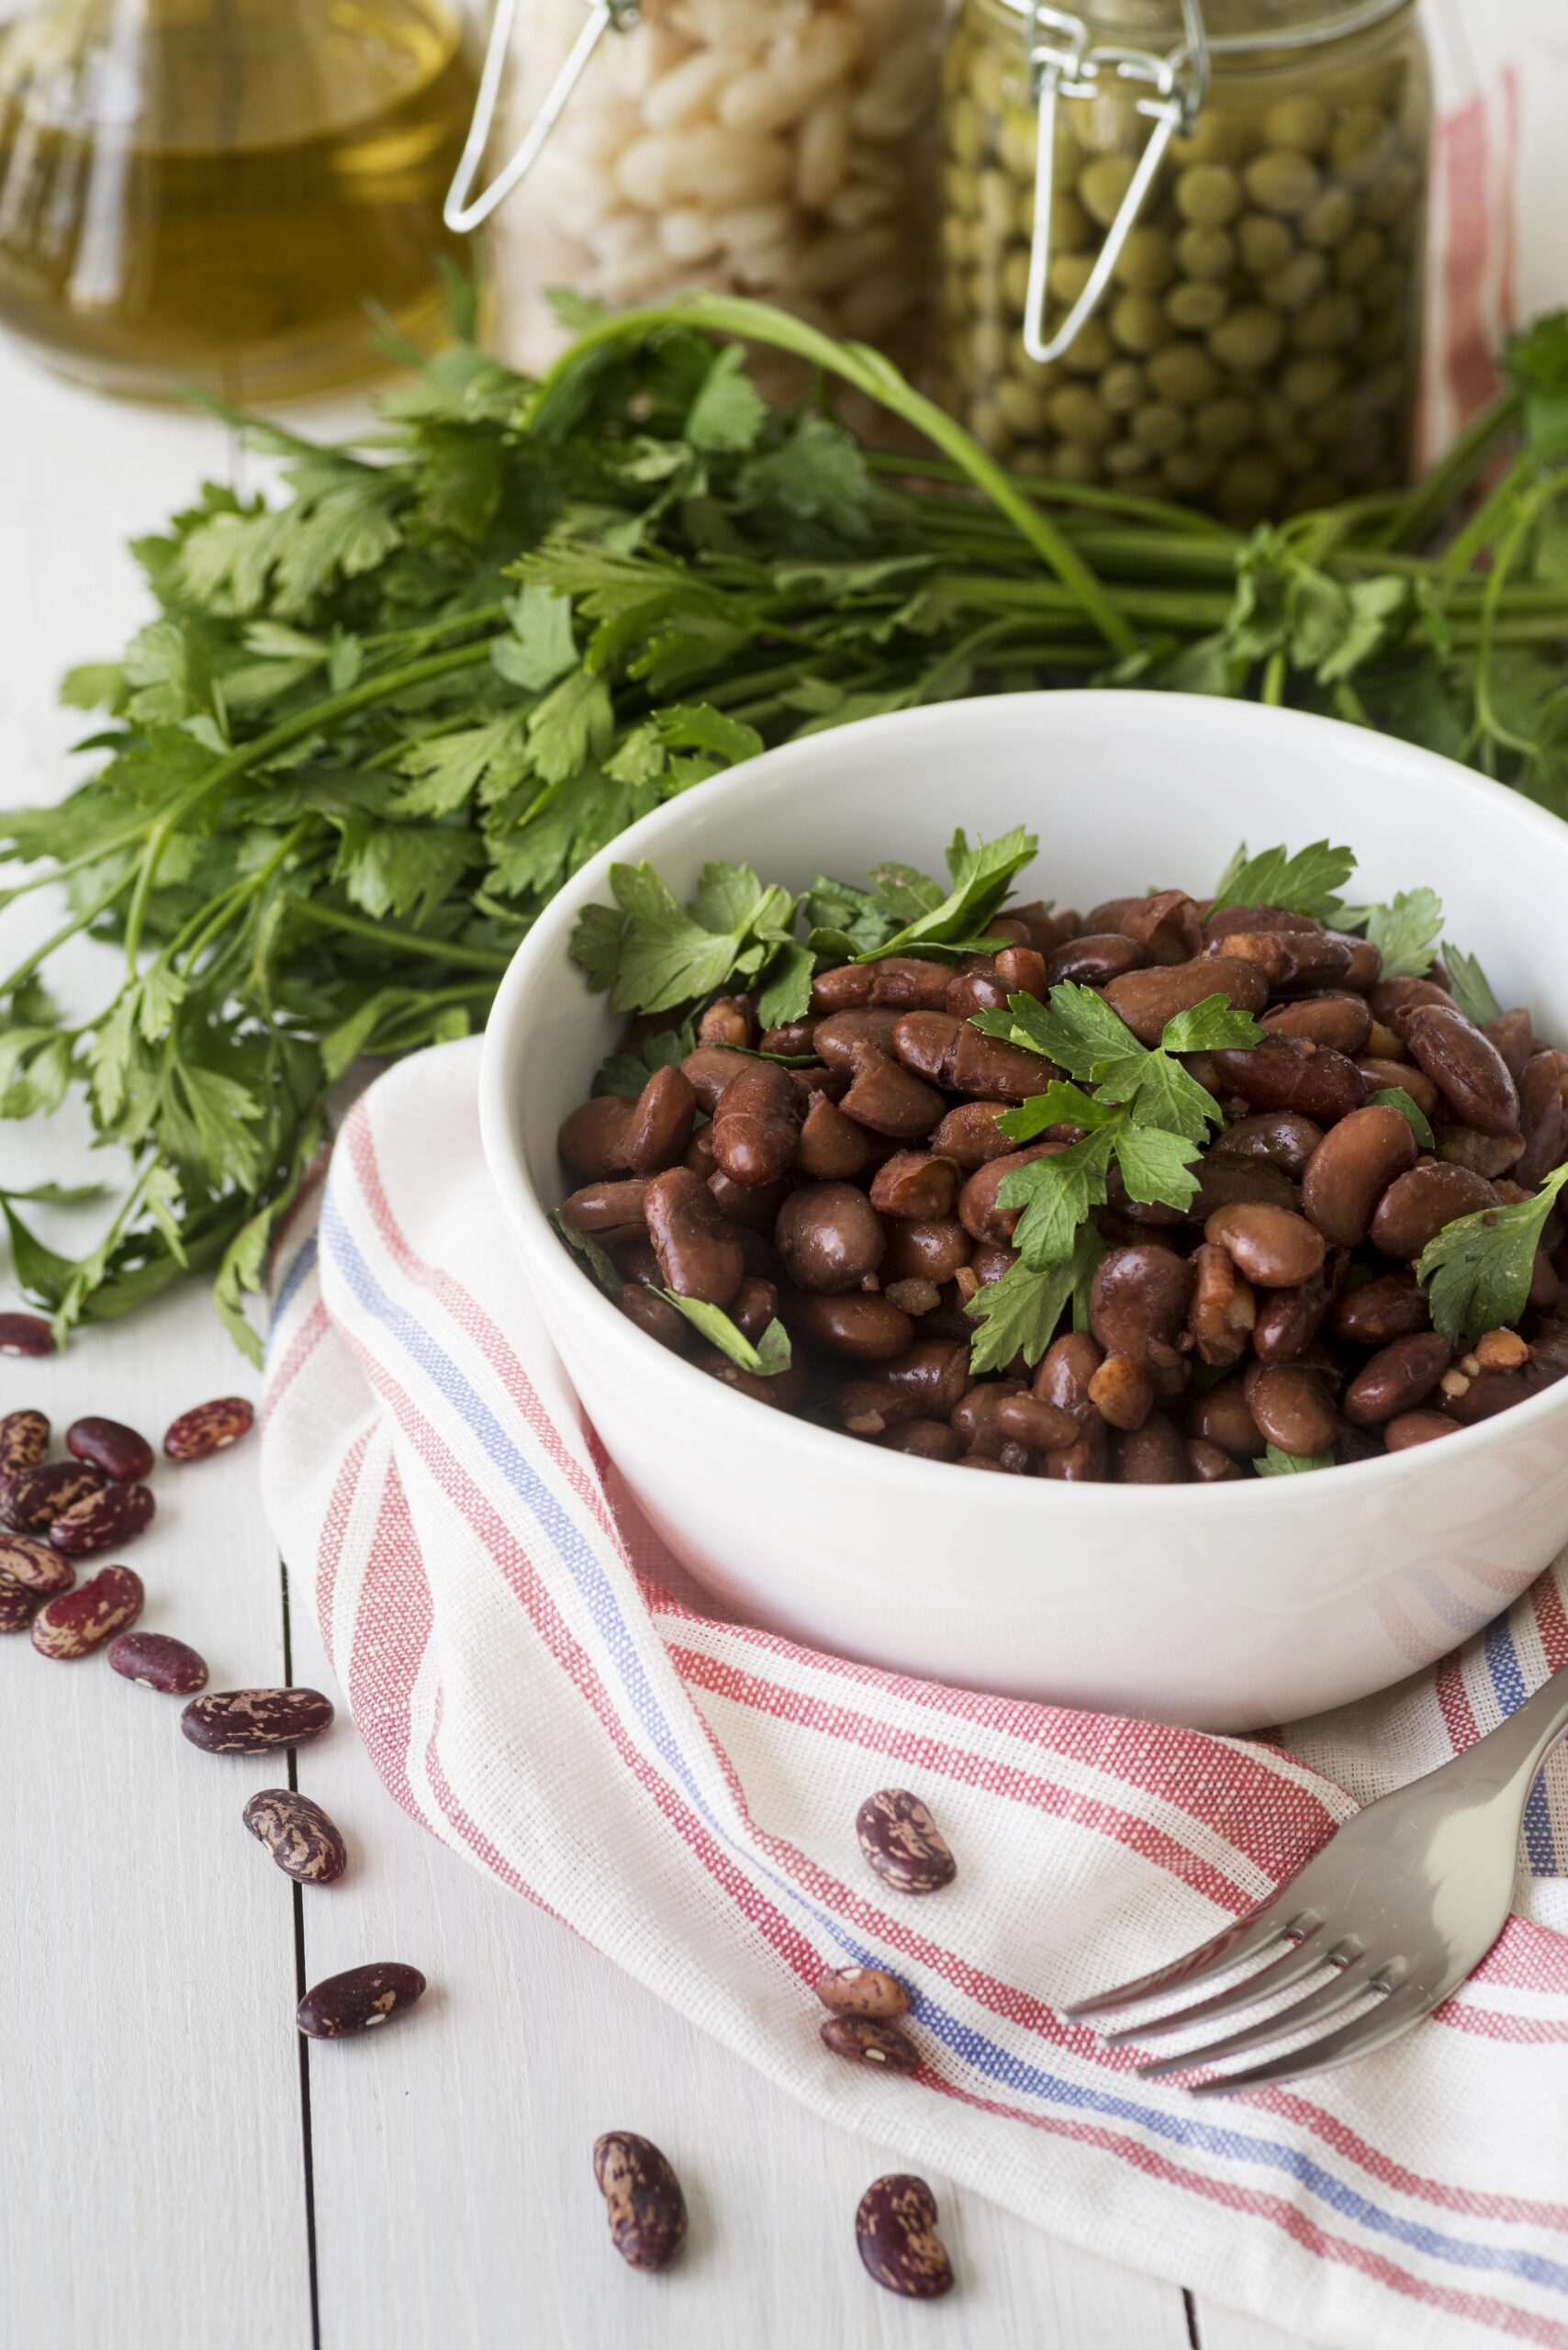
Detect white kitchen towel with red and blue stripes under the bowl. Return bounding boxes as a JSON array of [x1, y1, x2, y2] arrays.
[[263, 1041, 1568, 2350]]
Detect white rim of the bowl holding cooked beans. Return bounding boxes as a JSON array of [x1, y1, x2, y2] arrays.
[[479, 687, 1568, 1528]]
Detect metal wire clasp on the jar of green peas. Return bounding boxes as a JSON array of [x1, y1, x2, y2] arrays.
[[1023, 0, 1208, 366]]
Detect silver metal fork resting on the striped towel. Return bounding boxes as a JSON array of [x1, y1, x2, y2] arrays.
[[1065, 1669, 1568, 2097]]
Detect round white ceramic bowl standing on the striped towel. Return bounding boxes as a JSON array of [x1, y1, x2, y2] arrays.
[[482, 693, 1568, 1729]]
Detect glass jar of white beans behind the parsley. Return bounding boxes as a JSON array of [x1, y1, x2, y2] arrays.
[[475, 0, 945, 389]]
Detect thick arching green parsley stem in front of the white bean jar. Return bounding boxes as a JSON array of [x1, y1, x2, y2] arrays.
[[529, 294, 1137, 655]]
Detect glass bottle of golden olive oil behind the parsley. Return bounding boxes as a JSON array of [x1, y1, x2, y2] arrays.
[[0, 0, 475, 404]]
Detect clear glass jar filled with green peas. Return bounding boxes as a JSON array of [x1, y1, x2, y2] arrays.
[[940, 0, 1431, 526]]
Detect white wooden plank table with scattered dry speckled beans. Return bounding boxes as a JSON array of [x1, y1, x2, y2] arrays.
[[0, 326, 1303, 2350]]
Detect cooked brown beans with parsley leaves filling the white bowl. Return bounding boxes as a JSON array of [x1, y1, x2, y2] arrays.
[[557, 830, 1568, 1485]]
